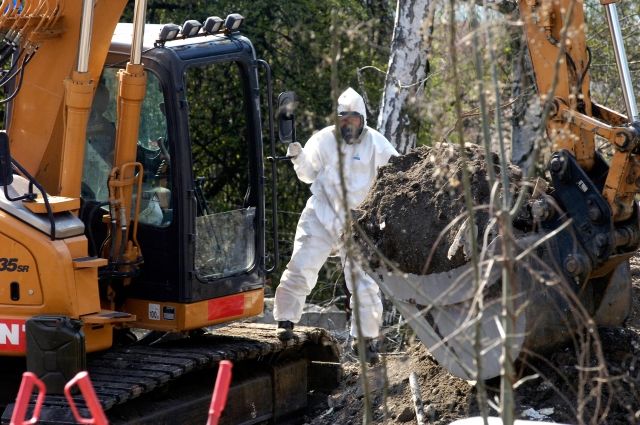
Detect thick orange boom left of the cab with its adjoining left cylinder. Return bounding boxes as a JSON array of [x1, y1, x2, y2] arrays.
[[6, 0, 127, 191]]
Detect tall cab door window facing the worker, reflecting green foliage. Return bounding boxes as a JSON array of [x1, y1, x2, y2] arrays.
[[185, 62, 256, 280]]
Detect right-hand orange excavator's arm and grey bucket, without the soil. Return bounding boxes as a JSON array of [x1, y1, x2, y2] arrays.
[[372, 0, 640, 380]]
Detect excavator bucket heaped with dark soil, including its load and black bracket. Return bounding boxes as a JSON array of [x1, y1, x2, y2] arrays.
[[354, 134, 640, 380]]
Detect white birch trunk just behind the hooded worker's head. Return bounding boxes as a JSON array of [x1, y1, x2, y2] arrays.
[[378, 0, 433, 154]]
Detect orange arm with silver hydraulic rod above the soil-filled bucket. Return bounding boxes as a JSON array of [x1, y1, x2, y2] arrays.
[[520, 0, 640, 222]]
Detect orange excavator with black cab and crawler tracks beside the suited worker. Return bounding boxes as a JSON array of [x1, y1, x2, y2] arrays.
[[0, 0, 338, 423]]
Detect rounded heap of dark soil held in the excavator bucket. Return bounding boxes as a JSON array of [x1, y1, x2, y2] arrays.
[[354, 143, 522, 274]]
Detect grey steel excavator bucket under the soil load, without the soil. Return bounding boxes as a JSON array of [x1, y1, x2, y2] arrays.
[[372, 235, 631, 380]]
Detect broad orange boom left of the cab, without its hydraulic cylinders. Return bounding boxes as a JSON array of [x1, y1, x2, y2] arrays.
[[3, 0, 127, 190]]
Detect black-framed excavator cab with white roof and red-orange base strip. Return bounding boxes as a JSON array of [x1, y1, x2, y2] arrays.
[[81, 24, 265, 331]]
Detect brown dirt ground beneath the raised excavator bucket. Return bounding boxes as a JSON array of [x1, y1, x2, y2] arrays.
[[304, 256, 640, 425]]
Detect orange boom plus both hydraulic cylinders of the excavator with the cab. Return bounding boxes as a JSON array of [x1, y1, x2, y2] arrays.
[[3, 0, 146, 290]]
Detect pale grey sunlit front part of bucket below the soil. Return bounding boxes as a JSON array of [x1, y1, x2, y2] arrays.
[[372, 234, 526, 380]]
